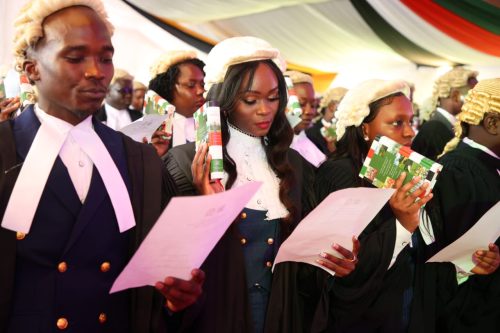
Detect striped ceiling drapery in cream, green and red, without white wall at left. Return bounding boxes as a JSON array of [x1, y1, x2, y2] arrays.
[[129, 0, 500, 72]]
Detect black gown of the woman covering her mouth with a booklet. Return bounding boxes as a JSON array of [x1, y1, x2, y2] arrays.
[[269, 158, 456, 332]]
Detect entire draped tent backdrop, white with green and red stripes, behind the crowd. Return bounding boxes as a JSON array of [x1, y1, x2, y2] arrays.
[[0, 0, 500, 102]]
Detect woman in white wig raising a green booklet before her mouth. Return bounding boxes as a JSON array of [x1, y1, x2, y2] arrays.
[[306, 80, 498, 332]]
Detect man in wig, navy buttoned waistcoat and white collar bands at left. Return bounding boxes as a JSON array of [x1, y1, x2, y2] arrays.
[[0, 0, 204, 333]]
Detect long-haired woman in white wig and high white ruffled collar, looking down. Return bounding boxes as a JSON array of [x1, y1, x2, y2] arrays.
[[166, 37, 355, 332]]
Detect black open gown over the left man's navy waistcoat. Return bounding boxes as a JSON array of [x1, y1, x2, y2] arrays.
[[0, 107, 177, 333]]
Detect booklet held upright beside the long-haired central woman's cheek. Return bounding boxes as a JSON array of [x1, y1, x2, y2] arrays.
[[193, 101, 224, 180]]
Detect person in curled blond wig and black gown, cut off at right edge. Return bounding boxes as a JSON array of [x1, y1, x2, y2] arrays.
[[427, 79, 500, 332]]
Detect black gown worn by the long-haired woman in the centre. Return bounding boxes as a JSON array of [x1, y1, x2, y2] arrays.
[[165, 143, 315, 333]]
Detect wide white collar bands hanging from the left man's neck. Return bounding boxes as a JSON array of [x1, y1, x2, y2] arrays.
[[1, 106, 135, 234]]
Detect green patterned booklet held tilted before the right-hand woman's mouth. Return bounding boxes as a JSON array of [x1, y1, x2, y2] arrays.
[[359, 136, 443, 196]]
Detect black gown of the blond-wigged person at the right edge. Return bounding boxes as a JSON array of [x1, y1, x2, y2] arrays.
[[426, 142, 500, 332]]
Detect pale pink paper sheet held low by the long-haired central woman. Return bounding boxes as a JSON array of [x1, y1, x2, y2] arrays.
[[274, 187, 394, 275]]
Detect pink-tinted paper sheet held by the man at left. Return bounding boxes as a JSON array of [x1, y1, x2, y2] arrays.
[[110, 182, 262, 293]]
